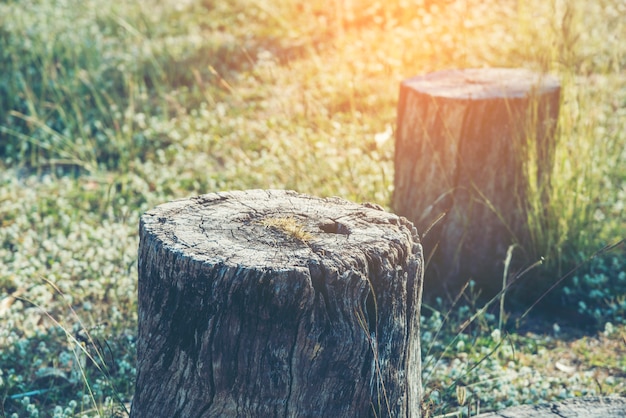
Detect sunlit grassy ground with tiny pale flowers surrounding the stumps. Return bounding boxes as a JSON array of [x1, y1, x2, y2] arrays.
[[0, 0, 626, 417]]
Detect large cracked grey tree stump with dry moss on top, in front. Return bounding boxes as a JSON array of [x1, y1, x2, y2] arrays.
[[131, 190, 423, 418]]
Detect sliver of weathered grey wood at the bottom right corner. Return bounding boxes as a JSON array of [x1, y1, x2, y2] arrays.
[[476, 397, 626, 418]]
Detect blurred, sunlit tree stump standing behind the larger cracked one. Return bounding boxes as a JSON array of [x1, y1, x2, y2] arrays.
[[392, 68, 560, 296]]
